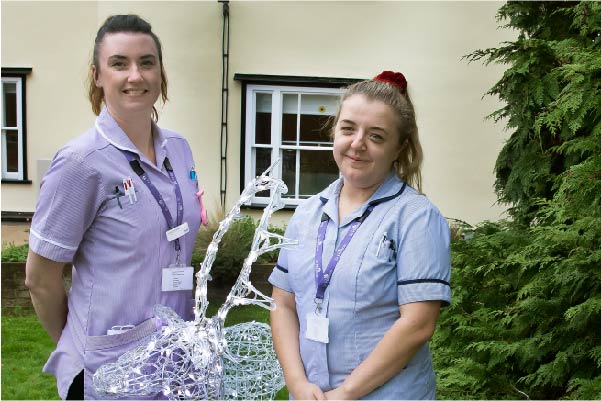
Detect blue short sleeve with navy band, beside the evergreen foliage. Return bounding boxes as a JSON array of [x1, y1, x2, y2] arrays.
[[397, 203, 451, 306]]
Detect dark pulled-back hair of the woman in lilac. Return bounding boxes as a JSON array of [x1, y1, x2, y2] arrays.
[[88, 14, 168, 121]]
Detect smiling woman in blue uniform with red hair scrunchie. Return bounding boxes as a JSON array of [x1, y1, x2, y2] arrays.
[[269, 71, 450, 399]]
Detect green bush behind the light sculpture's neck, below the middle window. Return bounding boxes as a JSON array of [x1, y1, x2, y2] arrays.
[[192, 216, 284, 285]]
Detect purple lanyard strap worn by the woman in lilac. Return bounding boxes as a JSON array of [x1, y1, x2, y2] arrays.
[[121, 150, 184, 255]]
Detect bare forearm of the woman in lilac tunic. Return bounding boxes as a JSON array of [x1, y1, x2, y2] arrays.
[[25, 251, 67, 343]]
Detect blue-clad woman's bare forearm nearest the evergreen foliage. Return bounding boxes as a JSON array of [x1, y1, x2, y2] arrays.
[[326, 305, 439, 399]]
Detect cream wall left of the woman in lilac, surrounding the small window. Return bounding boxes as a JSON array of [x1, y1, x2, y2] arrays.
[[2, 1, 96, 212]]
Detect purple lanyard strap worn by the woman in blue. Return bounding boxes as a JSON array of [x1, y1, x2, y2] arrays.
[[315, 205, 375, 304]]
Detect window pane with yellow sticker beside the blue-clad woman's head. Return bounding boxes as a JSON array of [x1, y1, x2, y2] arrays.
[[300, 95, 338, 146]]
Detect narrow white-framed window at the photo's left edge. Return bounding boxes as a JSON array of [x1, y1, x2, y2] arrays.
[[1, 77, 26, 181]]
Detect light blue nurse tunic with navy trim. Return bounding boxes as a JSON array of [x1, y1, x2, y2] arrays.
[[269, 172, 451, 399]]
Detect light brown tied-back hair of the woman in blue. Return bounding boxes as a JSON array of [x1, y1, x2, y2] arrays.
[[331, 80, 424, 192]]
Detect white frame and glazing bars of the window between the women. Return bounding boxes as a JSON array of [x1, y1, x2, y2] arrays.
[[244, 84, 344, 207]]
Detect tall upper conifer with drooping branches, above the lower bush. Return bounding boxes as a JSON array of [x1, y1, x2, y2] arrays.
[[467, 2, 601, 223]]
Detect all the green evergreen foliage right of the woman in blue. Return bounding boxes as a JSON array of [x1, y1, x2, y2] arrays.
[[433, 2, 601, 399]]
